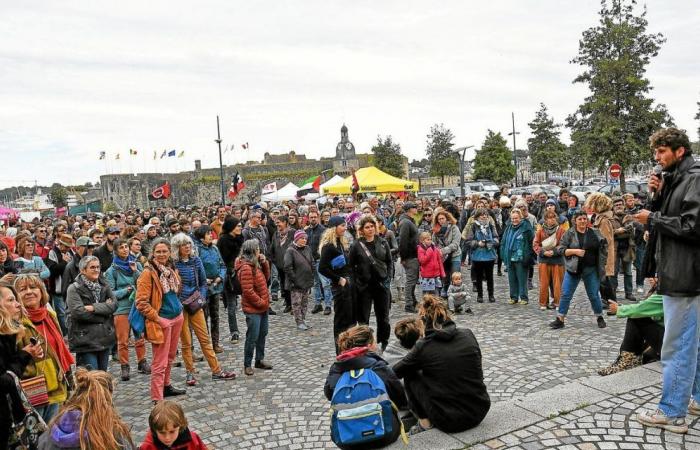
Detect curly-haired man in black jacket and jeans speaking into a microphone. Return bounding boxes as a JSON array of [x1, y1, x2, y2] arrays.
[[635, 128, 700, 433]]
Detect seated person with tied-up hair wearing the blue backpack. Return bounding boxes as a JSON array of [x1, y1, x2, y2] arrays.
[[323, 325, 408, 449]]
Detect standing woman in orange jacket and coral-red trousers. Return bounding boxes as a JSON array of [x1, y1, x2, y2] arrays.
[[136, 238, 185, 402]]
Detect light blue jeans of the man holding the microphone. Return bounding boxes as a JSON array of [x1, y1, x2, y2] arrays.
[[659, 295, 700, 417]]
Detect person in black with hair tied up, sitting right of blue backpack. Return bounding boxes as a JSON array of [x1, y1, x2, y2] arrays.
[[393, 295, 491, 434]]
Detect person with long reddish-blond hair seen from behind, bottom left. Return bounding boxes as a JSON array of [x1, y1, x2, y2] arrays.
[[39, 367, 136, 450]]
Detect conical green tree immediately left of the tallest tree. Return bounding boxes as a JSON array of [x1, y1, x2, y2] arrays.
[[527, 103, 569, 178]]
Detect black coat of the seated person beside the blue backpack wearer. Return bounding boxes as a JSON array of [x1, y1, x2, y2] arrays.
[[394, 321, 491, 433]]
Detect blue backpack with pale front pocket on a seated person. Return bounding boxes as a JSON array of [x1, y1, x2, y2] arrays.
[[331, 369, 407, 446]]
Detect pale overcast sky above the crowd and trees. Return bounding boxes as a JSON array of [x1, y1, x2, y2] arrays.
[[0, 0, 700, 188]]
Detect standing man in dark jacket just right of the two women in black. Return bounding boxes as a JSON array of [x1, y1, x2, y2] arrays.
[[399, 202, 420, 313]]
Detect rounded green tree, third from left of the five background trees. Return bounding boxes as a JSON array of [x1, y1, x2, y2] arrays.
[[474, 130, 515, 184]]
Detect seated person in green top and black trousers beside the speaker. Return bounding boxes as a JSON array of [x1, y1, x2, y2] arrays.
[[598, 279, 664, 376]]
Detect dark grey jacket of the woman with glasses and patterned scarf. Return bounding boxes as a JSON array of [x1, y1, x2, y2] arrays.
[[66, 277, 117, 353]]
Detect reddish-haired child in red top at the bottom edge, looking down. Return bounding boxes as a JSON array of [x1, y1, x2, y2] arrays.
[[139, 400, 207, 450]]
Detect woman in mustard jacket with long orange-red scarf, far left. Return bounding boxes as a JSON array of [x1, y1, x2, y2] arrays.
[[14, 274, 75, 422]]
